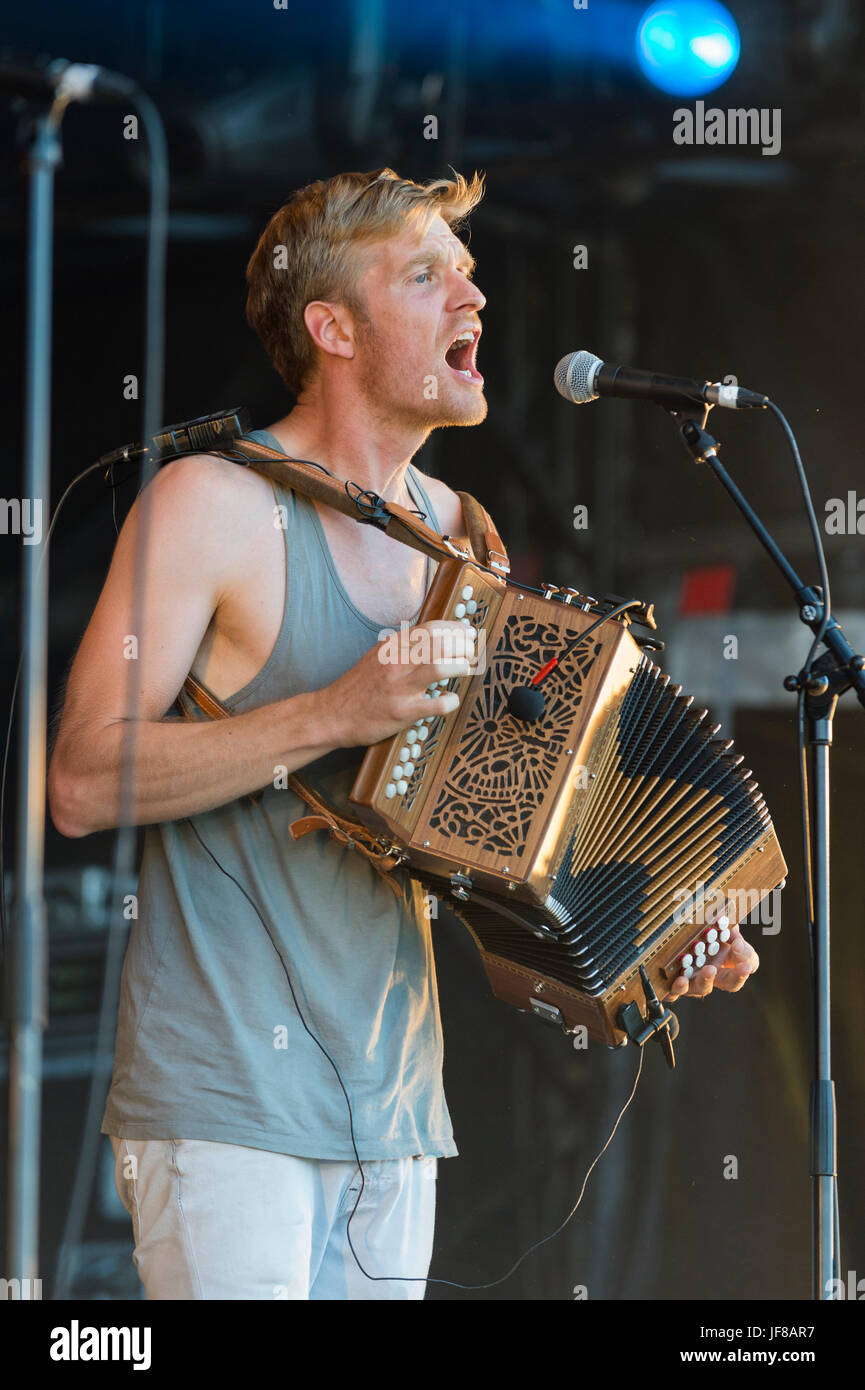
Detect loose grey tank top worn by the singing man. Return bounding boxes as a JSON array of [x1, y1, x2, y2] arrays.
[[102, 430, 456, 1159]]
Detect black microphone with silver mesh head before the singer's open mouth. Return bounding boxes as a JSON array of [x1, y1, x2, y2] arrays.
[[553, 352, 769, 410]]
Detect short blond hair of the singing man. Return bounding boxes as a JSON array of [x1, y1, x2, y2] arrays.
[[246, 168, 484, 395]]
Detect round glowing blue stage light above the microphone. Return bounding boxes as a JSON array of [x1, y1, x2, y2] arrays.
[[637, 0, 740, 96]]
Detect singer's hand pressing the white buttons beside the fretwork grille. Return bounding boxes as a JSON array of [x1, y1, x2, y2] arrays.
[[320, 619, 476, 748]]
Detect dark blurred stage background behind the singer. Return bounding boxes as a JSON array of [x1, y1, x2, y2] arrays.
[[0, 0, 865, 1301]]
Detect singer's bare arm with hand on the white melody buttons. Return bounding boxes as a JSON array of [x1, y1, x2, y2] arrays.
[[49, 457, 467, 837]]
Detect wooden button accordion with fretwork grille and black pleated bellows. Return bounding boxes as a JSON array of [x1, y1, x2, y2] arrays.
[[350, 559, 786, 1047]]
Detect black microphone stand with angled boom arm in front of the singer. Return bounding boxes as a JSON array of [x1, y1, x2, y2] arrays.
[[663, 403, 865, 1301]]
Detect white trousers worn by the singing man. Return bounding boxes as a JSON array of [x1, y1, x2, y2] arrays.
[[111, 1136, 438, 1300]]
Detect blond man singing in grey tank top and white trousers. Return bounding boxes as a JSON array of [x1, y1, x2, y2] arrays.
[[49, 170, 757, 1300]]
